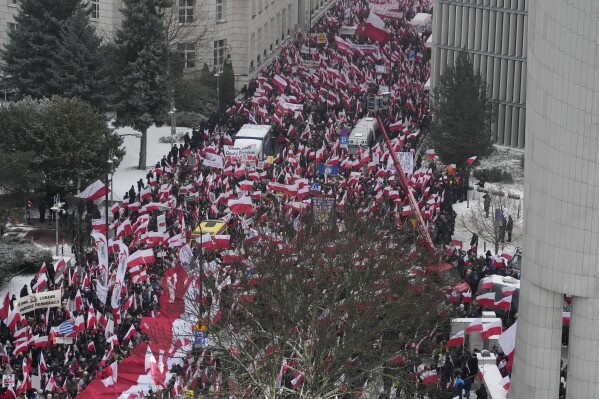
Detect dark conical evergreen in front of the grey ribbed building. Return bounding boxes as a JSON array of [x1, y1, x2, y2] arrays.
[[431, 51, 493, 166]]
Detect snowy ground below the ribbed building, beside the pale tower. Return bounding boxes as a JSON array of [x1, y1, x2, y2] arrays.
[[453, 146, 524, 255]]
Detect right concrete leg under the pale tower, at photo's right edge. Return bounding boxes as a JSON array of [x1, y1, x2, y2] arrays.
[[567, 296, 599, 399]]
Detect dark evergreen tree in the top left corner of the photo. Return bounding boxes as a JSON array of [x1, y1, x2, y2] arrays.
[[2, 0, 84, 98]]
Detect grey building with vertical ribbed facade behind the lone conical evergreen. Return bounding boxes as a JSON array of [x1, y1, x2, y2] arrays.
[[431, 0, 528, 148]]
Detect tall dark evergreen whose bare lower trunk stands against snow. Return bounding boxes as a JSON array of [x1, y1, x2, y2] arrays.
[[116, 0, 172, 169]]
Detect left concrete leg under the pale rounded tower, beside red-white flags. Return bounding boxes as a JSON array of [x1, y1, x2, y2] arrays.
[[510, 282, 570, 399]]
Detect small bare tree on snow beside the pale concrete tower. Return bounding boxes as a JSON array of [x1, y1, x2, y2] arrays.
[[462, 187, 522, 254]]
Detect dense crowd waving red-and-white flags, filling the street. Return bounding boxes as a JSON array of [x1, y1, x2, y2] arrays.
[[0, 0, 536, 399]]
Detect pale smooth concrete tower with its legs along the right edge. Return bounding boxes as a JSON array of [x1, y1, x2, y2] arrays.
[[509, 0, 599, 399]]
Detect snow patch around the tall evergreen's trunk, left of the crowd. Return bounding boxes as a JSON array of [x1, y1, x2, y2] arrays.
[[113, 126, 191, 200]]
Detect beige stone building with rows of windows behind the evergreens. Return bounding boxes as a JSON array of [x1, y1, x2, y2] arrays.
[[0, 0, 333, 88]]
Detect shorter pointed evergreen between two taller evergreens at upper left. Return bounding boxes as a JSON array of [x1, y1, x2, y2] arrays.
[[49, 10, 111, 111]]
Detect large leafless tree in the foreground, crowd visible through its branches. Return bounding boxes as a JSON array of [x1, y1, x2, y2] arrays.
[[179, 219, 450, 399]]
